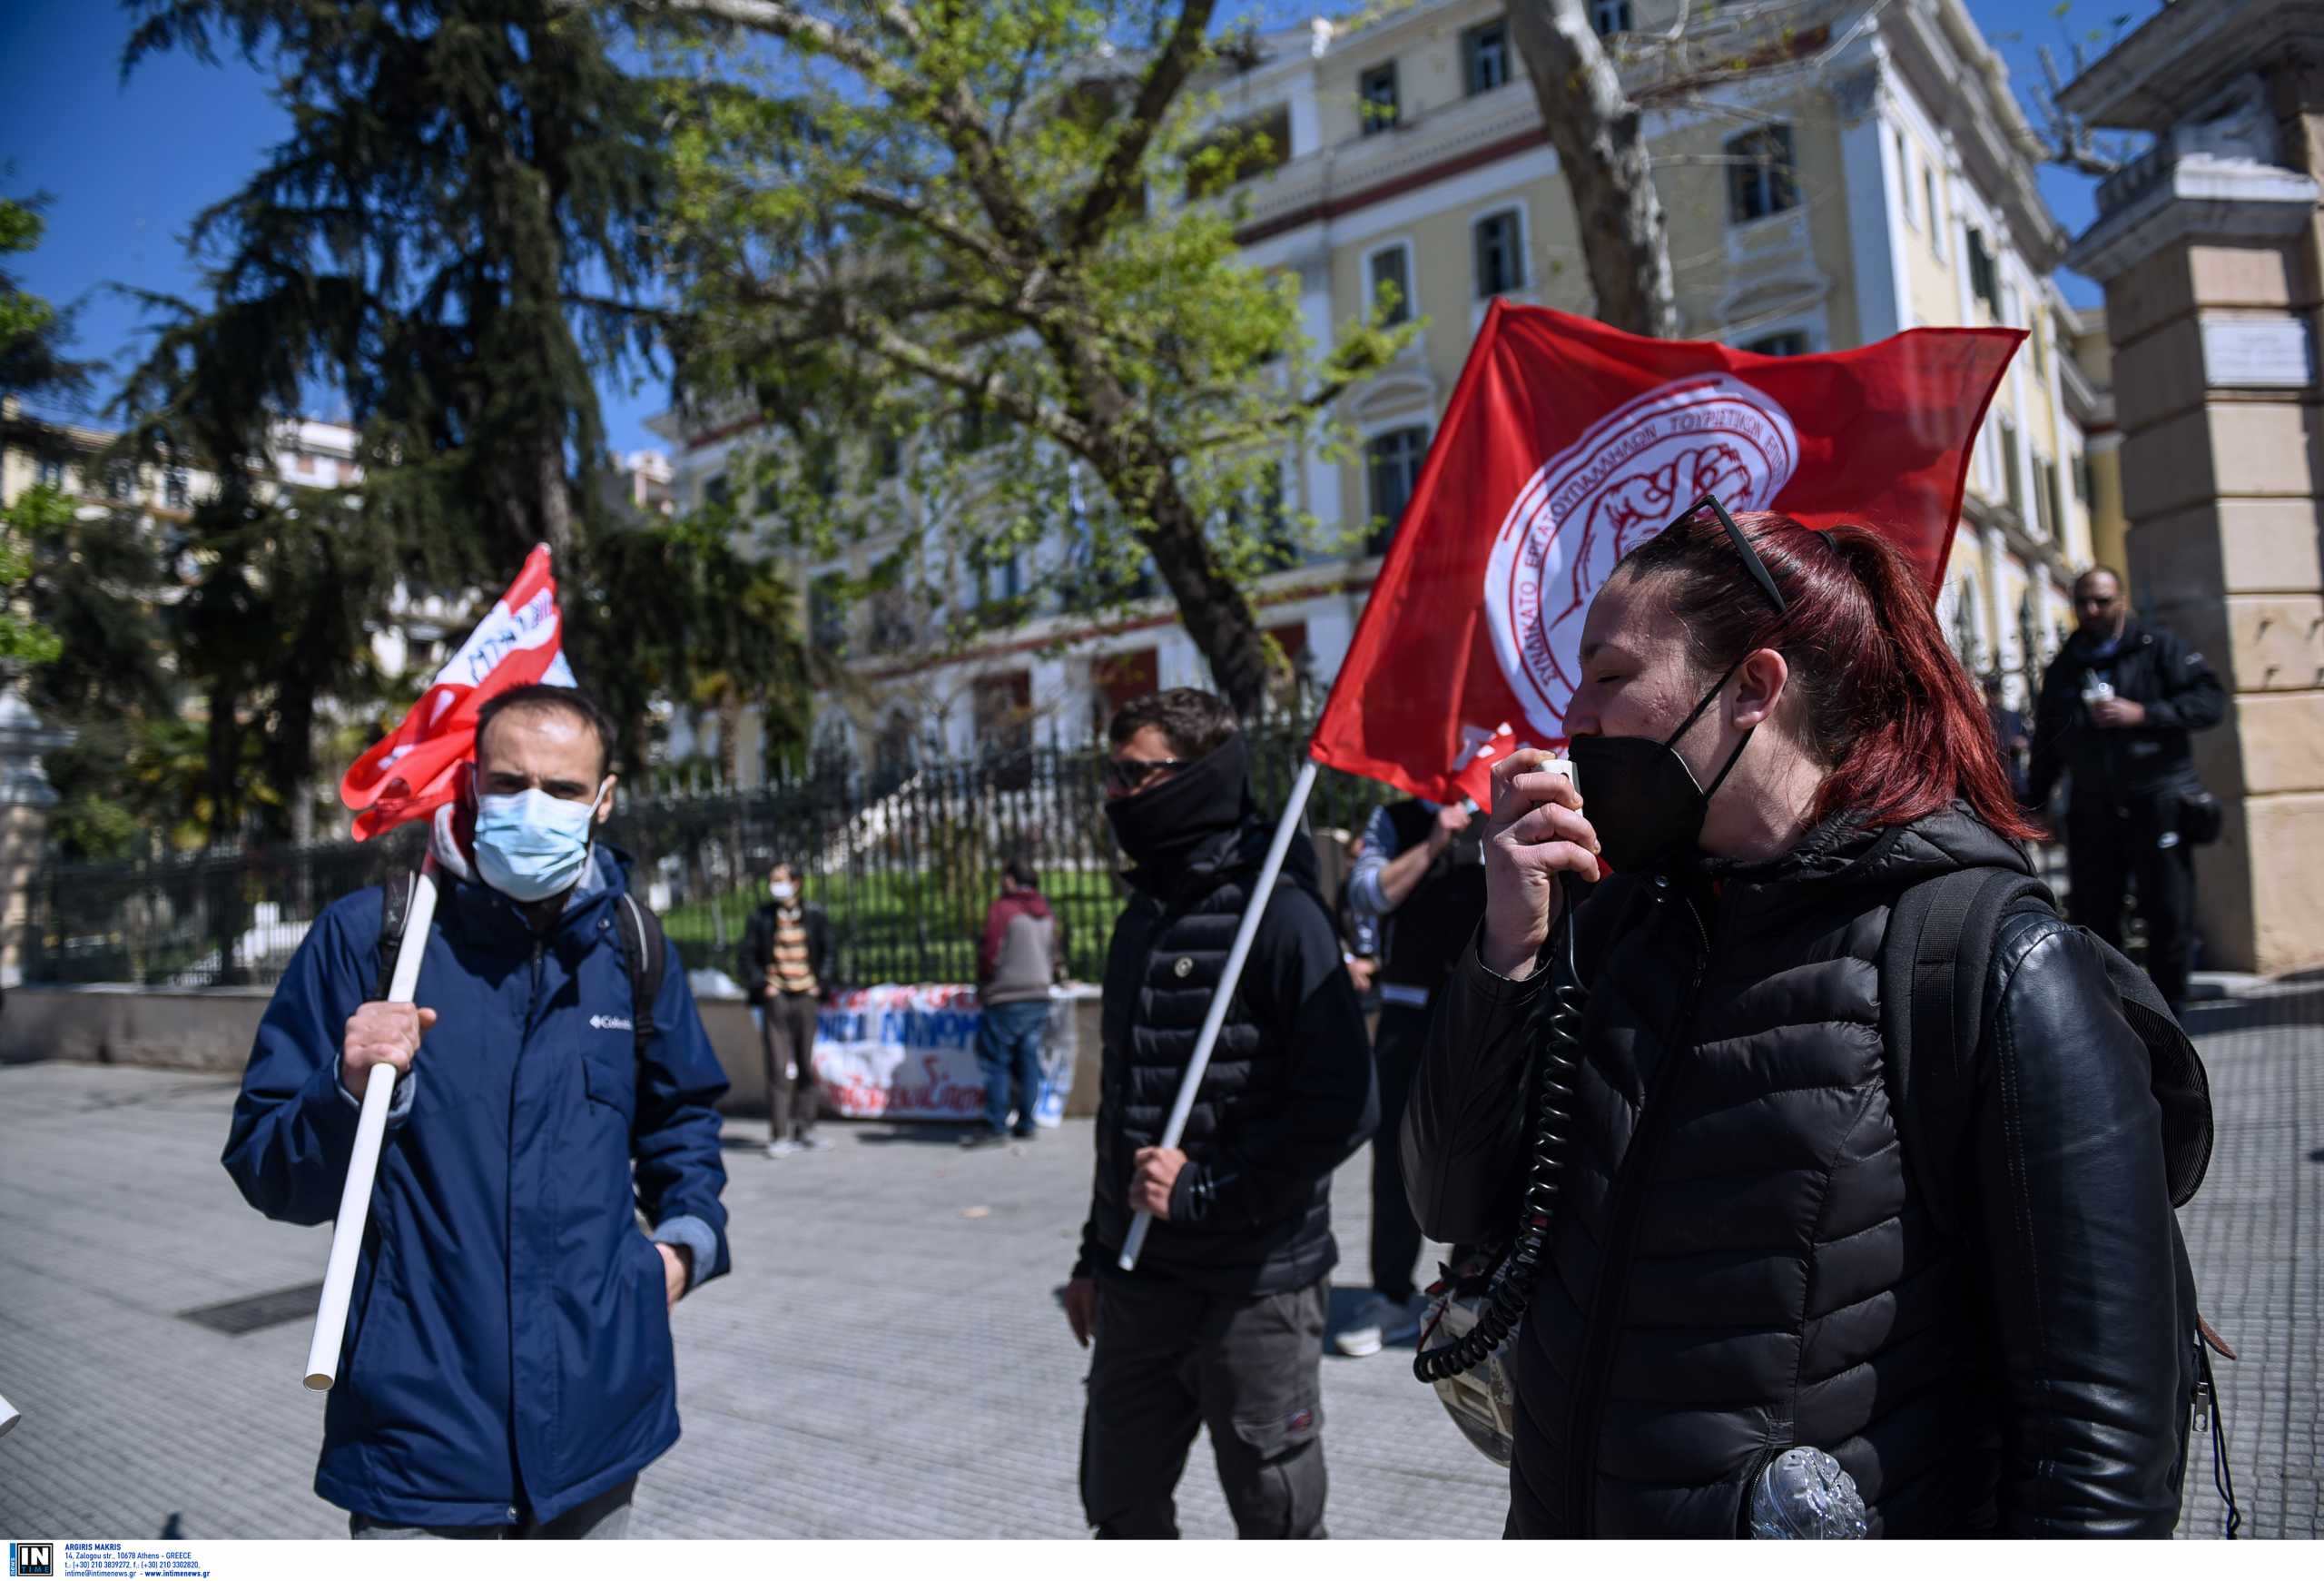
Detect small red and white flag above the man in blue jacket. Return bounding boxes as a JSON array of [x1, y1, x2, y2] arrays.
[[340, 544, 576, 839]]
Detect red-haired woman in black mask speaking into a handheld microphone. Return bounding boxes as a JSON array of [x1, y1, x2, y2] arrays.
[[1402, 502, 2196, 1537]]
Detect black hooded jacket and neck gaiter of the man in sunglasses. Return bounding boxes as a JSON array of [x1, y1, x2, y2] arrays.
[[1074, 742, 1381, 1295]]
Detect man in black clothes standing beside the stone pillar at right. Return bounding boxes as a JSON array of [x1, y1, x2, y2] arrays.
[[2026, 565, 2226, 1012]]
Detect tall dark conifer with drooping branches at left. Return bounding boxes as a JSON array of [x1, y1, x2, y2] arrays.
[[123, 0, 660, 718]]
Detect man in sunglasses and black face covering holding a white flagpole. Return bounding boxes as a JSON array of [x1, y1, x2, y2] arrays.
[[1064, 688, 1378, 1537]]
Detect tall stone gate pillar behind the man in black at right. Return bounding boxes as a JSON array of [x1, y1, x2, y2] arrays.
[[2068, 71, 2324, 972]]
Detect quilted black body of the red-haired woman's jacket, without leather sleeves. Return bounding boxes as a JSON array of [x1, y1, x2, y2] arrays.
[[1511, 814, 2024, 1537]]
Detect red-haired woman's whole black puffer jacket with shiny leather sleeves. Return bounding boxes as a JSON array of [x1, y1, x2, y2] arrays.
[[1402, 809, 2194, 1537]]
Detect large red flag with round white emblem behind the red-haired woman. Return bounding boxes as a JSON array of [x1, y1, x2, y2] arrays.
[[1308, 302, 2024, 802]]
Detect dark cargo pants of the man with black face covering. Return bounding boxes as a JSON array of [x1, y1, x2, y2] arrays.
[[1080, 1271, 1329, 1537]]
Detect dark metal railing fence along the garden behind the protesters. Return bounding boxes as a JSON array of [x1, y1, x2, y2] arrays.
[[25, 721, 1392, 988]]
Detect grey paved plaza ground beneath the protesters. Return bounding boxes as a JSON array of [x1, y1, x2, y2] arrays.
[[0, 981, 2324, 1537]]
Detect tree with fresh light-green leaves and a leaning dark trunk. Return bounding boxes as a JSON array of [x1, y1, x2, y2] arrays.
[[632, 0, 1411, 711]]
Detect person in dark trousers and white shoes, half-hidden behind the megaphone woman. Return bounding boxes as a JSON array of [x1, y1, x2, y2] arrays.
[[1332, 800, 1485, 1356]]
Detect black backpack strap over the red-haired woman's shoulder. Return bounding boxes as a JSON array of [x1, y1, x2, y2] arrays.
[[1880, 867, 2057, 1235]]
